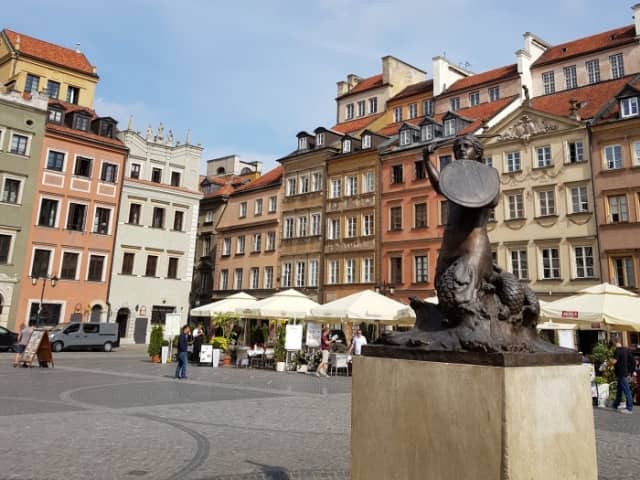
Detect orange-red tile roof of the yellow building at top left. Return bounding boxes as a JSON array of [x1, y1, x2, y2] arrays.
[[2, 28, 97, 77]]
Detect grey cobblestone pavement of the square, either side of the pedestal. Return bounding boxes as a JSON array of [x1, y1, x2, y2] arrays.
[[0, 346, 640, 480]]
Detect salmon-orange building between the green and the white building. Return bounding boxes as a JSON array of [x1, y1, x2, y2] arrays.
[[16, 101, 127, 325]]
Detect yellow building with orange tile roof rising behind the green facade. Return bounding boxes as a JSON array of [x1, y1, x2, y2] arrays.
[[0, 28, 99, 108]]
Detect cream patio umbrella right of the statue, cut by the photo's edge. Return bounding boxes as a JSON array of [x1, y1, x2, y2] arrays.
[[540, 283, 640, 331]]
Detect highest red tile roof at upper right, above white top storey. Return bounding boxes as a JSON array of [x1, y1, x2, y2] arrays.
[[532, 25, 636, 67]]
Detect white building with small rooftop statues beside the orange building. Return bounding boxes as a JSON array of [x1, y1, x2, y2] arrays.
[[109, 122, 202, 343]]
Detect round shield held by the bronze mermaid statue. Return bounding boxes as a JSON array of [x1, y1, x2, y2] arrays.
[[440, 160, 500, 208]]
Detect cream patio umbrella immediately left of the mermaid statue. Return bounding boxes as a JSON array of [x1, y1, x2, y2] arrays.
[[311, 290, 416, 324]]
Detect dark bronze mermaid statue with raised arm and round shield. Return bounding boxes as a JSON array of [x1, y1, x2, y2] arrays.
[[382, 136, 556, 352]]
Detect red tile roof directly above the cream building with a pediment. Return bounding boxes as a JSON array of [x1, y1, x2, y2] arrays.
[[531, 75, 634, 120]]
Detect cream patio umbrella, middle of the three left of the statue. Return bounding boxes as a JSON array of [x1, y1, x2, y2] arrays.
[[236, 288, 320, 320]]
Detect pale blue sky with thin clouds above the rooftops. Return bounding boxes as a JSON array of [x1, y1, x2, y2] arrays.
[[2, 0, 635, 170]]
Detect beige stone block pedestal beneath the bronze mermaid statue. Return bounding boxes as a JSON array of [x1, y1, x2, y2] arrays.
[[351, 349, 597, 480]]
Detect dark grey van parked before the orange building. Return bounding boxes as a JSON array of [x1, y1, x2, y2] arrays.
[[49, 323, 120, 352]]
